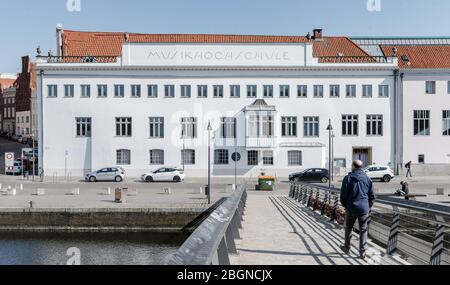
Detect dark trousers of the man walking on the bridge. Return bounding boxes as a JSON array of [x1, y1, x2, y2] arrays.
[[344, 211, 370, 254]]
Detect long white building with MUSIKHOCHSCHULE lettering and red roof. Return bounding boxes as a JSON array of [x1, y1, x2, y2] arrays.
[[37, 30, 397, 178]]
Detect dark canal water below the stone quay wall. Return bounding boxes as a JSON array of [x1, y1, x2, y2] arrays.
[[0, 232, 188, 265]]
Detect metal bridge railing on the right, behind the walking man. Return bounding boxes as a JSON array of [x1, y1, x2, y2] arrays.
[[289, 183, 450, 265]]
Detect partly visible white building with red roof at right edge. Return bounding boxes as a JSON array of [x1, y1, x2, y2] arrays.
[[354, 37, 450, 175]]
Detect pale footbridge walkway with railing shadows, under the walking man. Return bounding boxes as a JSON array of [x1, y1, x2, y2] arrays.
[[231, 192, 407, 265]]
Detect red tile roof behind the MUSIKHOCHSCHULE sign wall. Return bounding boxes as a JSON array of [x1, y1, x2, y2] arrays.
[[62, 30, 368, 62]]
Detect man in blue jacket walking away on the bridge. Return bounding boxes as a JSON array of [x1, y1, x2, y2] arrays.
[[341, 160, 375, 259]]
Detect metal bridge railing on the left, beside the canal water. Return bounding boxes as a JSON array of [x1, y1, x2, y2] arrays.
[[166, 186, 247, 265]]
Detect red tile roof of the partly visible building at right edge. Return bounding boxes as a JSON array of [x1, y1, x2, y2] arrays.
[[381, 45, 450, 69]]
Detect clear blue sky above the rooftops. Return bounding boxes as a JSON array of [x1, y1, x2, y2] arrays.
[[0, 0, 450, 73]]
